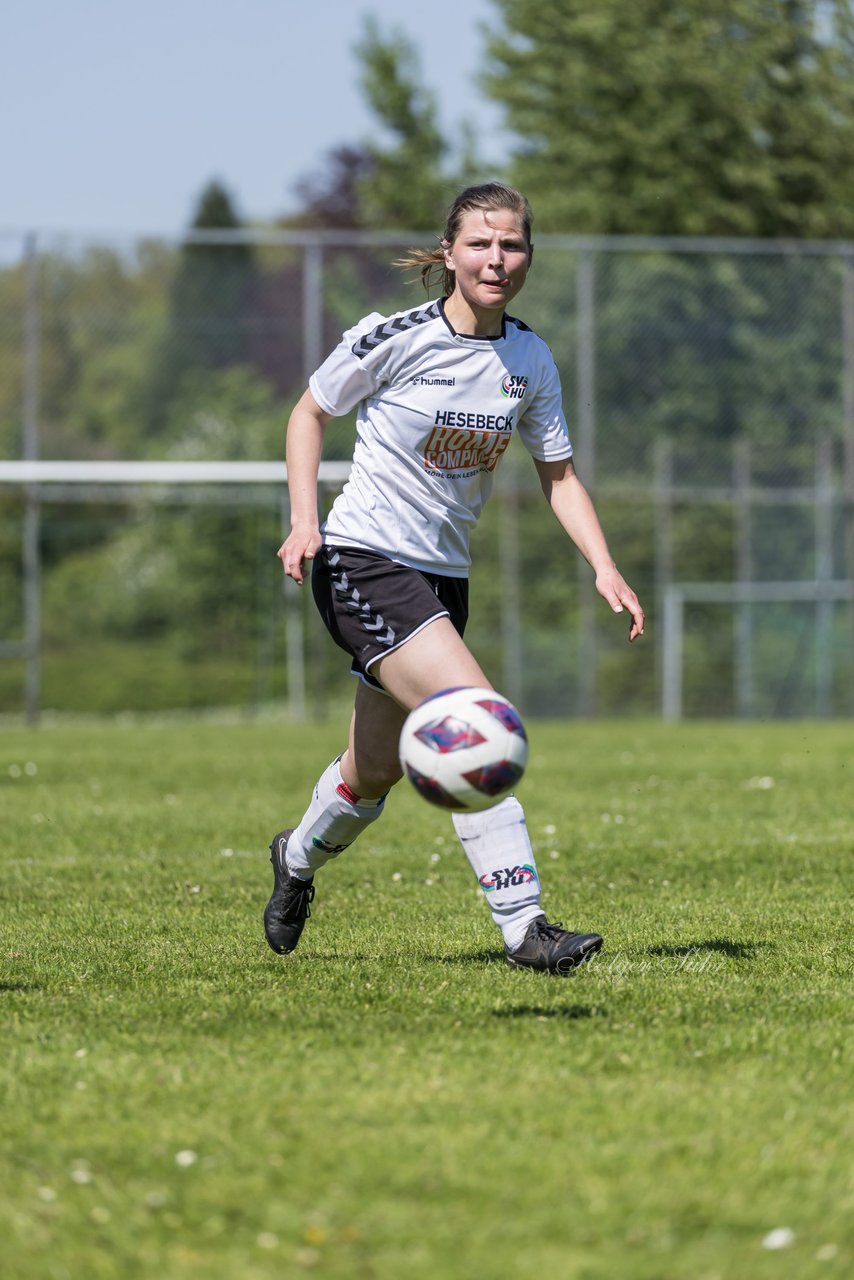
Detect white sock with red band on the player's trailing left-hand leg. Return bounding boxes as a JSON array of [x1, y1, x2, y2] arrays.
[[286, 756, 385, 879]]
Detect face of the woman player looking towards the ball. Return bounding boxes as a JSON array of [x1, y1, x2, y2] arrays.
[[444, 209, 531, 312]]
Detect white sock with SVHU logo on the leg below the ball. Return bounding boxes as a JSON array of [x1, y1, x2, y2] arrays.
[[452, 796, 543, 951]]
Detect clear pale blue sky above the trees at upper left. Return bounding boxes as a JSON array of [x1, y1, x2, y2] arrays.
[[0, 0, 502, 234]]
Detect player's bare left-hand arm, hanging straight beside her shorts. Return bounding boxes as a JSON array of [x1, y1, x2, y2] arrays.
[[277, 390, 332, 586]]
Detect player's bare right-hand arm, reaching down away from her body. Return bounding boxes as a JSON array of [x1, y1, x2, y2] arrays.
[[534, 458, 644, 640]]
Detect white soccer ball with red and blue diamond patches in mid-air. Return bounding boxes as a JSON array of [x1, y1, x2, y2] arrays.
[[401, 687, 528, 812]]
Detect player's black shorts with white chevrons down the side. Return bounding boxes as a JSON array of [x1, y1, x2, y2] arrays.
[[311, 545, 469, 689]]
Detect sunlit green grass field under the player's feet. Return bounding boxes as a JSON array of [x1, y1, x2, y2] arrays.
[[0, 721, 854, 1280]]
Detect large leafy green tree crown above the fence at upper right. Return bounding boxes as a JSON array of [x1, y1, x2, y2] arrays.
[[485, 0, 854, 237]]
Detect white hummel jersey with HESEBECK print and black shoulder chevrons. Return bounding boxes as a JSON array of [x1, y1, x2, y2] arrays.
[[309, 294, 572, 577]]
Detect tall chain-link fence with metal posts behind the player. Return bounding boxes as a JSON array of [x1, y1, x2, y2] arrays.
[[0, 232, 854, 719]]
